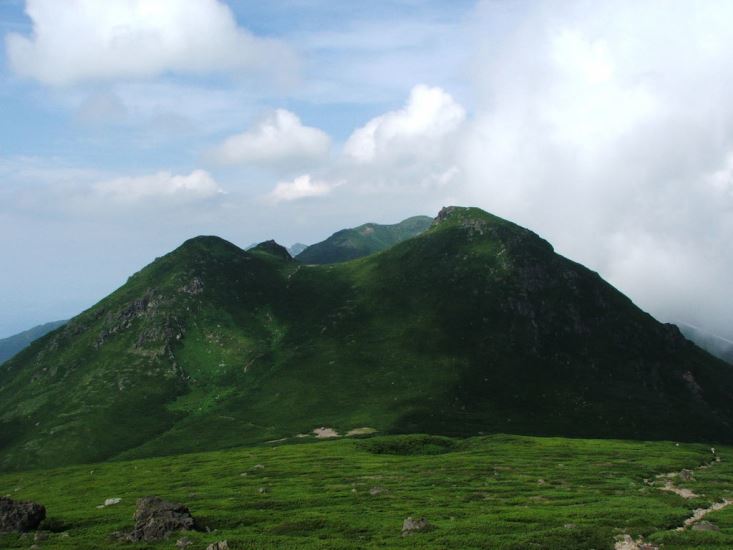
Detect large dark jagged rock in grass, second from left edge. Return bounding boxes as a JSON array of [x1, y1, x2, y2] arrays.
[[117, 497, 196, 542]]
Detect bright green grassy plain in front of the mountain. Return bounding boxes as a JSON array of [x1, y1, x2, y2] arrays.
[[0, 435, 733, 550]]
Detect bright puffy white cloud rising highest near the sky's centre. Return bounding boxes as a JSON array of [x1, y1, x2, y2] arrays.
[[344, 85, 466, 163]]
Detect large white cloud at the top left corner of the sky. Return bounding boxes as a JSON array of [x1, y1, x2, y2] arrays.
[[6, 0, 295, 85]]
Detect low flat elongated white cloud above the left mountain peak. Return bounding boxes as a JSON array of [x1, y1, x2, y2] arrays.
[[93, 170, 224, 202]]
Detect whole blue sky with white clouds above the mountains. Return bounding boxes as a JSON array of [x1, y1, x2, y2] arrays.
[[0, 0, 733, 339]]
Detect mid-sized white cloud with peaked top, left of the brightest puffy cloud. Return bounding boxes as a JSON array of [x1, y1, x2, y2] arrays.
[[210, 109, 331, 164]]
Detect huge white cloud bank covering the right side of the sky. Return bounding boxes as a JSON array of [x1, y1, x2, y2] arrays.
[[458, 0, 733, 337]]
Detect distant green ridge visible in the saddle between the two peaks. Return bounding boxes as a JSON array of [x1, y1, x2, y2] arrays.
[[295, 216, 433, 264]]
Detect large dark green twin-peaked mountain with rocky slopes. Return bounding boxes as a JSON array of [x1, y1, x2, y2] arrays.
[[0, 207, 733, 469]]
